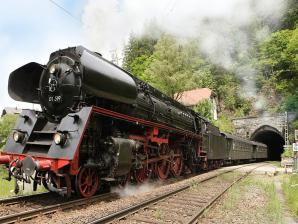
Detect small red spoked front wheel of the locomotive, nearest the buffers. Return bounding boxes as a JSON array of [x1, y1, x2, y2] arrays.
[[76, 167, 99, 198]]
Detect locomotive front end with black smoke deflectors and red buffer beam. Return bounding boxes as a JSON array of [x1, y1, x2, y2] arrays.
[[0, 46, 137, 197]]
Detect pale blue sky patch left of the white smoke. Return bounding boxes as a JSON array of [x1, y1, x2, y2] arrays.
[[0, 0, 85, 111]]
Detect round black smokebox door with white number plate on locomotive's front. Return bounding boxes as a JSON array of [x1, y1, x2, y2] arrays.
[[39, 51, 83, 120]]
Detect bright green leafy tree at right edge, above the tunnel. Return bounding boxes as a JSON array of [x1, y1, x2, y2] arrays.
[[259, 23, 298, 114]]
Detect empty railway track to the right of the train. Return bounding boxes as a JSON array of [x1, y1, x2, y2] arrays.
[[89, 164, 264, 224]]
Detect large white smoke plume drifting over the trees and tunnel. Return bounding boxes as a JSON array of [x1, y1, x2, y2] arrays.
[[82, 0, 286, 108]]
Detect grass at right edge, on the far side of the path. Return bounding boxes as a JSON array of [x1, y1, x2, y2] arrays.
[[282, 174, 298, 217]]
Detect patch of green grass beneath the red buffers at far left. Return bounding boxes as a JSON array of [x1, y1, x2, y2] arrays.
[[0, 165, 46, 198]]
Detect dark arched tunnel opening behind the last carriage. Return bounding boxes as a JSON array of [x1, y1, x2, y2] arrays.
[[251, 125, 285, 160]]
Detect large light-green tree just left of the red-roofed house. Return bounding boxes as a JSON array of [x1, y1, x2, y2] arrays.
[[145, 35, 210, 99]]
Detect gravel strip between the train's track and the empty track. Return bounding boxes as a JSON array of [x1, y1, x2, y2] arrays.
[[18, 166, 251, 224]]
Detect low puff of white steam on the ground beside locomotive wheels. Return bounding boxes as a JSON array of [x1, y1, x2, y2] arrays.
[[111, 181, 162, 197]]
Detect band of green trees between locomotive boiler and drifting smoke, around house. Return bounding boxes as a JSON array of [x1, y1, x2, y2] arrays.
[[123, 31, 251, 118]]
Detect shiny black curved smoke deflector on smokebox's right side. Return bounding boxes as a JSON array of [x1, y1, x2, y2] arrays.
[[78, 47, 137, 104]]
